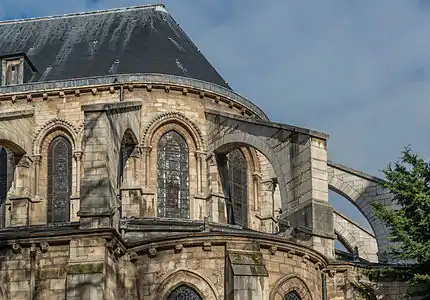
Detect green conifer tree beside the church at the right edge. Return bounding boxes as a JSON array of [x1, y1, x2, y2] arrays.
[[373, 147, 430, 299]]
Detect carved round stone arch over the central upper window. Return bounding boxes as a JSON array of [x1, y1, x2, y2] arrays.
[[142, 112, 205, 151]]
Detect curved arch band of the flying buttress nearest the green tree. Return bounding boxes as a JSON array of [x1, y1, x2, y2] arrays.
[[328, 176, 388, 260]]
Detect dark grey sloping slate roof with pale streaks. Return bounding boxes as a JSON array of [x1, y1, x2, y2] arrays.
[[0, 5, 230, 88]]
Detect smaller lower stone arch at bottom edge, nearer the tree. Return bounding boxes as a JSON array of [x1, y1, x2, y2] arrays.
[[269, 274, 313, 300]]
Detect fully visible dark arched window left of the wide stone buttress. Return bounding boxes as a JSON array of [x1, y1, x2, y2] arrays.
[[48, 136, 72, 223]]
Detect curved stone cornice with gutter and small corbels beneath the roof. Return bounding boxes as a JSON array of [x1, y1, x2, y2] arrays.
[[0, 73, 269, 121]]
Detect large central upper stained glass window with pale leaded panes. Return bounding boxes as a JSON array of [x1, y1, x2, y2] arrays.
[[157, 131, 190, 218]]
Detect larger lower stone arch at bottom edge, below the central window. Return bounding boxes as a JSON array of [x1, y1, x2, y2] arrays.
[[152, 269, 220, 300]]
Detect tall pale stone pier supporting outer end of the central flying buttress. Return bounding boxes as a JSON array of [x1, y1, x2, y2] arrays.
[[282, 133, 335, 257]]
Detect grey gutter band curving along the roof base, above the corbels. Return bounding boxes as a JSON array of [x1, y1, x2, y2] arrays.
[[0, 73, 269, 121]]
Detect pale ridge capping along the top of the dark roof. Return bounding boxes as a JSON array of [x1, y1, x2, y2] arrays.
[[0, 3, 167, 25]]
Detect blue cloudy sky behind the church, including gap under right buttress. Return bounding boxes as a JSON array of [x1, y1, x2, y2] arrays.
[[0, 0, 430, 232]]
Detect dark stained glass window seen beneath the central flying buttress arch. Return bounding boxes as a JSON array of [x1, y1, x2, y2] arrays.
[[227, 150, 247, 226]]
